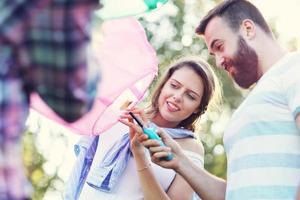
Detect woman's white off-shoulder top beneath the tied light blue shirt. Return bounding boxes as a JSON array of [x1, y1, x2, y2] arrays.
[[79, 122, 204, 200]]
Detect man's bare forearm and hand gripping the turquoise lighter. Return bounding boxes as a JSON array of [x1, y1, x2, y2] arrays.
[[143, 130, 226, 200]]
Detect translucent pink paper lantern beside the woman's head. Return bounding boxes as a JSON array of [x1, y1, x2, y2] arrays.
[[30, 17, 158, 135]]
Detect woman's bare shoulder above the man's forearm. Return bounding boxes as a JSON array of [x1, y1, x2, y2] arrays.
[[175, 138, 204, 157]]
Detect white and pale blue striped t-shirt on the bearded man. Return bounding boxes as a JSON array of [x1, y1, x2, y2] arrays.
[[224, 53, 300, 200]]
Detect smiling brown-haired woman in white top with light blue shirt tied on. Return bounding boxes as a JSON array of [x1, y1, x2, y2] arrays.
[[65, 58, 220, 200]]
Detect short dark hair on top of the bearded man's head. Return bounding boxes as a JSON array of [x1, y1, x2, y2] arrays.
[[196, 0, 271, 35]]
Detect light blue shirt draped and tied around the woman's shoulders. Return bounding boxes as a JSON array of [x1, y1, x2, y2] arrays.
[[64, 123, 194, 200]]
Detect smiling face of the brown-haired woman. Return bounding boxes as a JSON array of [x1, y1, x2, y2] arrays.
[[156, 66, 204, 127]]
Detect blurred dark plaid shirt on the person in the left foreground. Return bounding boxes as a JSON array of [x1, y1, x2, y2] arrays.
[[0, 0, 99, 200]]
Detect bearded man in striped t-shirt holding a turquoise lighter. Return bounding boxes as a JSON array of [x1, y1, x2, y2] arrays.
[[144, 0, 300, 200]]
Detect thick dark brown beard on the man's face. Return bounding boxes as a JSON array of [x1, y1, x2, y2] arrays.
[[229, 36, 259, 89]]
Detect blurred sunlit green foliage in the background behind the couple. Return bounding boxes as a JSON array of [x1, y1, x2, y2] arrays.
[[23, 0, 293, 199]]
